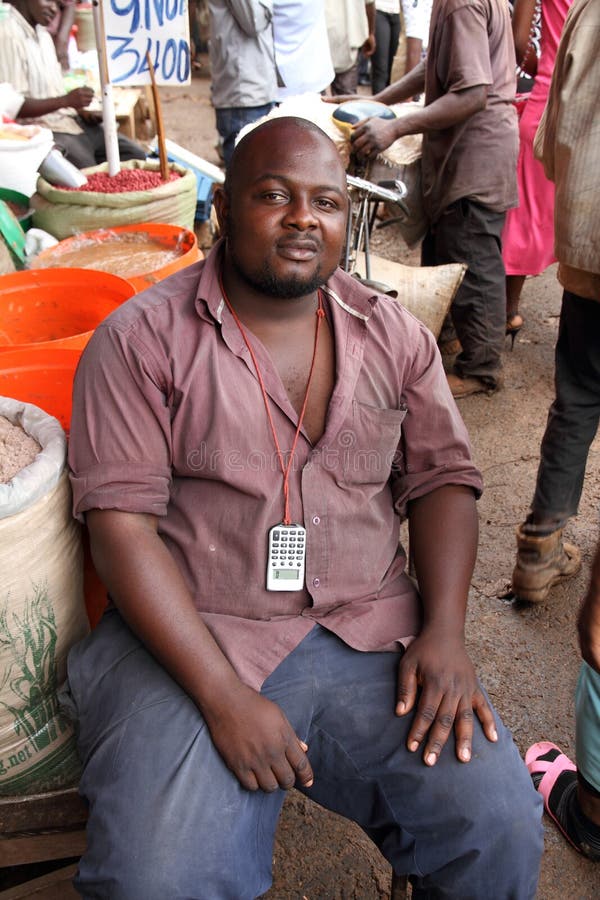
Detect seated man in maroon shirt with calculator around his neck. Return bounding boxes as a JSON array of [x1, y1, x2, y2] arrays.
[[64, 118, 542, 900]]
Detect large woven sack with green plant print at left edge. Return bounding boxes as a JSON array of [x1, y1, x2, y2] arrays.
[[0, 397, 88, 796]]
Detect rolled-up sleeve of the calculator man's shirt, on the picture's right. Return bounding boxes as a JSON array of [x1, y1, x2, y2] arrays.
[[392, 327, 483, 518]]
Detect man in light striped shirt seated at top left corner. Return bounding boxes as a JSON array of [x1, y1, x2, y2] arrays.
[[0, 0, 146, 169]]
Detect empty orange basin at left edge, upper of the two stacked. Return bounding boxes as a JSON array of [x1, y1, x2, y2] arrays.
[[0, 269, 135, 352]]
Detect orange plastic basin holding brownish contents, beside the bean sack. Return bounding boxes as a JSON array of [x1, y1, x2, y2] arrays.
[[32, 222, 204, 292]]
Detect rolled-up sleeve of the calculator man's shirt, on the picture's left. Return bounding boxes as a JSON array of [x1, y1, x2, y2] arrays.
[[69, 325, 172, 520]]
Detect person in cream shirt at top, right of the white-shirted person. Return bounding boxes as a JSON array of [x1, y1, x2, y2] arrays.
[[325, 0, 375, 94]]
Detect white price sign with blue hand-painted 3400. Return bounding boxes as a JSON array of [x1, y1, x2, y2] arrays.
[[102, 0, 190, 84]]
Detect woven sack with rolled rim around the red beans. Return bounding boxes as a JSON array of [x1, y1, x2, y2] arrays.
[[31, 159, 198, 241]]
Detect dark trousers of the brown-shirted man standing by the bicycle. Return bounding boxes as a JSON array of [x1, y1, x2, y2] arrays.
[[421, 198, 506, 387]]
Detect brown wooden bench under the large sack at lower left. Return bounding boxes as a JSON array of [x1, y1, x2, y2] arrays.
[[0, 787, 87, 900]]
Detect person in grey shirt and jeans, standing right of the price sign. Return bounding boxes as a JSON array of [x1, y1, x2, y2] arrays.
[[208, 0, 277, 166]]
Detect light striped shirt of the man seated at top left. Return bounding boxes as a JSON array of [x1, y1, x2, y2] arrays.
[[0, 6, 82, 134]]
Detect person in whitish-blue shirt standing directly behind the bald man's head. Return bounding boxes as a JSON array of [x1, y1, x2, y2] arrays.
[[273, 0, 335, 100]]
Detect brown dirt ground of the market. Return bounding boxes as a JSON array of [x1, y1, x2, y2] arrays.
[[156, 65, 600, 900]]
